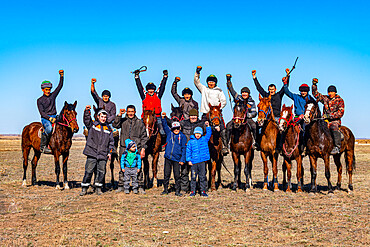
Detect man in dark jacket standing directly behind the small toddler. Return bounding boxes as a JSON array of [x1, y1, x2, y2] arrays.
[[113, 105, 149, 194]]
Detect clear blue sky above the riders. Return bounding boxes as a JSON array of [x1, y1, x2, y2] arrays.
[[0, 1, 370, 138]]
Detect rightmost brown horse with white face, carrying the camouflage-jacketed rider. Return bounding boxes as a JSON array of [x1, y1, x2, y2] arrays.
[[304, 101, 356, 193]]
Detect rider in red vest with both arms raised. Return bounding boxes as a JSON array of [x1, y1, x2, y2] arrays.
[[134, 70, 168, 136]]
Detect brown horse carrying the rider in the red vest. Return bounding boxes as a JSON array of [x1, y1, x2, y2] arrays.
[[143, 109, 165, 188]]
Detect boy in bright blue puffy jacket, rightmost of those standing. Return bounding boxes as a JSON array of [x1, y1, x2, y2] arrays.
[[186, 121, 212, 197]]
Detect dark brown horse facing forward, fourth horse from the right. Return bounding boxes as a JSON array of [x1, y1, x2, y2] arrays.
[[230, 101, 254, 191]]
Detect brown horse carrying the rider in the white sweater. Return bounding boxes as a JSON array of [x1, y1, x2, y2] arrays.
[[207, 104, 223, 191]]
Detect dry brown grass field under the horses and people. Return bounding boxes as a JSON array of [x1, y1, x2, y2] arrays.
[[0, 137, 370, 246]]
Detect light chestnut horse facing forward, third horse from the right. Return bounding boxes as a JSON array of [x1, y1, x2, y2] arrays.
[[257, 95, 279, 191]]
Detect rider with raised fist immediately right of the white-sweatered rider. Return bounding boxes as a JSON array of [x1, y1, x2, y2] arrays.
[[226, 74, 257, 149]]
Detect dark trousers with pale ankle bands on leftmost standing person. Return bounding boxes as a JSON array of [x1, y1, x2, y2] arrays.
[[81, 157, 107, 187]]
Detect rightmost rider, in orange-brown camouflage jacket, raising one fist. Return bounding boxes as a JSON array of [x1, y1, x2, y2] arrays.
[[312, 78, 344, 154]]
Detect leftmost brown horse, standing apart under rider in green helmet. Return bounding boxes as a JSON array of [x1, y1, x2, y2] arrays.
[[22, 101, 78, 189]]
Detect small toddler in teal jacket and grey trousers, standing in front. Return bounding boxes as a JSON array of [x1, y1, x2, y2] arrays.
[[121, 139, 141, 194]]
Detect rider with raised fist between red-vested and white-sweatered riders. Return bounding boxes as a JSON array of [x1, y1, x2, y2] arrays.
[[171, 77, 199, 121]]
